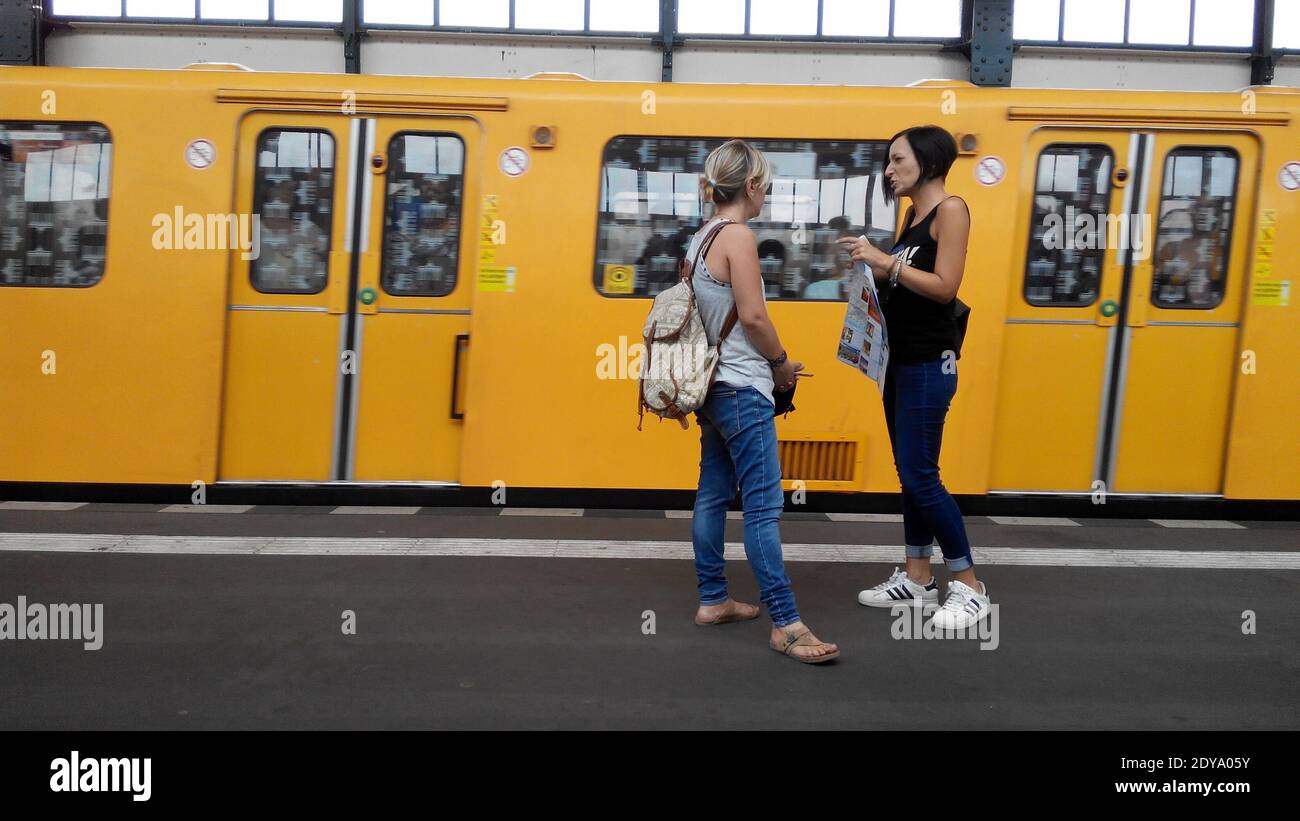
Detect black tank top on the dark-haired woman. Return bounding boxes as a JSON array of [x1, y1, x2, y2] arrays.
[[881, 197, 969, 365]]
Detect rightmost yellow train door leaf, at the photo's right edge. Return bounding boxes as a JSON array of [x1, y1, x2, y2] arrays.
[[1099, 131, 1258, 494]]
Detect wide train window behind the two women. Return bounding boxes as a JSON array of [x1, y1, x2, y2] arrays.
[[594, 136, 897, 300]]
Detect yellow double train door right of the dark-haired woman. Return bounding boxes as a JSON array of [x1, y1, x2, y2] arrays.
[[991, 129, 1256, 494]]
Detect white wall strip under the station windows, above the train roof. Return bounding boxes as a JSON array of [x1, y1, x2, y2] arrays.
[[47, 23, 1300, 91]]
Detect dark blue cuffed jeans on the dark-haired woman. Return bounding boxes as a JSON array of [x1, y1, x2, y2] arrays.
[[884, 357, 974, 570]]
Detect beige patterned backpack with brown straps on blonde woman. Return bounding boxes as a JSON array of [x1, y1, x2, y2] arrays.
[[637, 218, 737, 430]]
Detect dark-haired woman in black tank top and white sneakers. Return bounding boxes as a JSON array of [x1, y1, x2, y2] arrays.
[[839, 126, 989, 629]]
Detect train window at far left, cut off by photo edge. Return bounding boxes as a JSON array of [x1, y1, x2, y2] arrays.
[[0, 122, 113, 288]]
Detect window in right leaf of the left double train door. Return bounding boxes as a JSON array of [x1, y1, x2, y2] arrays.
[[381, 131, 465, 296]]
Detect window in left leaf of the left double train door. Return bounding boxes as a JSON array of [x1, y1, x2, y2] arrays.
[[248, 129, 334, 294]]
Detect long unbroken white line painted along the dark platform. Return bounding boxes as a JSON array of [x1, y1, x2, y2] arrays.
[[0, 533, 1300, 570]]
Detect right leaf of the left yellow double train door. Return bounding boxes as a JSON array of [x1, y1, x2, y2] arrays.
[[346, 117, 478, 482]]
